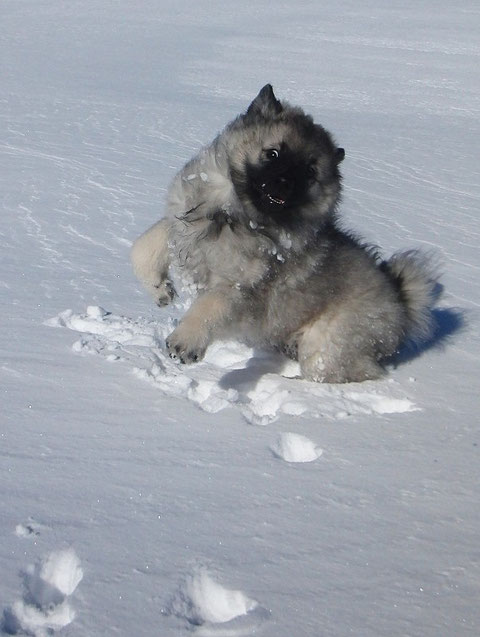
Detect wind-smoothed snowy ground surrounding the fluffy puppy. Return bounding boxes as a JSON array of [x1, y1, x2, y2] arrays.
[[0, 0, 480, 637]]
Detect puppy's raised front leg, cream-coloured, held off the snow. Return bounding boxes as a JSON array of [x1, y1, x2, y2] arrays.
[[131, 219, 175, 306]]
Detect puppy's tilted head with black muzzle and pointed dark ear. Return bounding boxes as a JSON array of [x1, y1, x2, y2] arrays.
[[227, 84, 345, 225]]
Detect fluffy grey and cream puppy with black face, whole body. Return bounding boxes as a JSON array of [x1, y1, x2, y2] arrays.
[[132, 84, 435, 383]]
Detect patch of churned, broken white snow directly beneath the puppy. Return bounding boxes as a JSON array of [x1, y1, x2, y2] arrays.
[[45, 306, 416, 425]]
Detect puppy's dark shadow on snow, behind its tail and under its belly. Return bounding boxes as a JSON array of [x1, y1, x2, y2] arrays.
[[219, 308, 466, 388]]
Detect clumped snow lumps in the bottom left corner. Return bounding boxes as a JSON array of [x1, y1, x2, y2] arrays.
[[3, 549, 83, 637]]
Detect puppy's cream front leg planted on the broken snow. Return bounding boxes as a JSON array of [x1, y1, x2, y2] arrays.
[[167, 290, 234, 363]]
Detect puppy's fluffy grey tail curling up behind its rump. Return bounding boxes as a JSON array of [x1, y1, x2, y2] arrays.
[[384, 250, 441, 342]]
